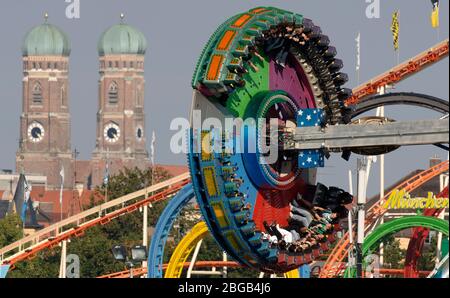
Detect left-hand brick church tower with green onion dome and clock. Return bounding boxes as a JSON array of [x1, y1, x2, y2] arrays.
[[16, 17, 73, 189]]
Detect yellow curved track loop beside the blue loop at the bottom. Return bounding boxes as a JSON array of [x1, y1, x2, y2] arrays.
[[164, 221, 300, 278]]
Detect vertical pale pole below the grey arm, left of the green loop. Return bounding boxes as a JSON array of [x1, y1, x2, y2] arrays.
[[356, 157, 369, 278]]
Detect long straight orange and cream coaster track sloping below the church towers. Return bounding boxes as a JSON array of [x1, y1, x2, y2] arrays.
[[0, 173, 190, 269]]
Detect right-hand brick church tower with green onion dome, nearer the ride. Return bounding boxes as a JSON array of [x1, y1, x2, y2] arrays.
[[91, 16, 149, 185]]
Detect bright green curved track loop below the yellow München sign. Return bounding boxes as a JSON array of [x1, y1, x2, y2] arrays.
[[345, 215, 449, 277]]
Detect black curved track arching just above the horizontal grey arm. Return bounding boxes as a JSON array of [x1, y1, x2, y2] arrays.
[[352, 92, 449, 118]]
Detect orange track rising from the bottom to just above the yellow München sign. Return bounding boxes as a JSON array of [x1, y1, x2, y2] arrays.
[[320, 160, 449, 278]]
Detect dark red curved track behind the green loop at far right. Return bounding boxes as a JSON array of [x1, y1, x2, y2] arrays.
[[404, 186, 448, 278]]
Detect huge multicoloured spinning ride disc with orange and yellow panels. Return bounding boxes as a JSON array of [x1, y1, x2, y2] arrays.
[[189, 7, 351, 272]]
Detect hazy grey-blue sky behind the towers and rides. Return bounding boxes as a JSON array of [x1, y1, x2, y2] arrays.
[[0, 0, 449, 194]]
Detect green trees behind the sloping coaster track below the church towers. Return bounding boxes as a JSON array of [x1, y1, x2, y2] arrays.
[[9, 168, 174, 278]]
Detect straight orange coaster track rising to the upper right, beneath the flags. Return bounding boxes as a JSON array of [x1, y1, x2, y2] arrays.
[[345, 39, 448, 106]]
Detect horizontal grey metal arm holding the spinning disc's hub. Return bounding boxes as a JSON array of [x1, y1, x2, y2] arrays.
[[284, 119, 449, 151]]
